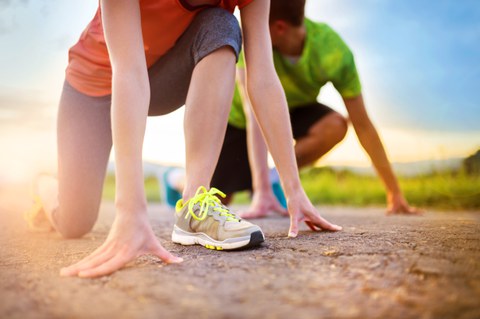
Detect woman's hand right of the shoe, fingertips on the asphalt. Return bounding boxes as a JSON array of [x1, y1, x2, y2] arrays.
[[287, 190, 342, 237]]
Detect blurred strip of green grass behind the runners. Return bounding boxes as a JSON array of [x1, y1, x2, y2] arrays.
[[104, 168, 480, 210]]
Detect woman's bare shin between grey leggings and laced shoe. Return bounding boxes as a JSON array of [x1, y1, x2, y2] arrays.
[[183, 47, 235, 200]]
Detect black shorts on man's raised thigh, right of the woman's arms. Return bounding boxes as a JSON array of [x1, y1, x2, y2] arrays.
[[290, 103, 335, 139]]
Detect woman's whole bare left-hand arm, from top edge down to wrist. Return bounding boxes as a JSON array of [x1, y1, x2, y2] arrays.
[[100, 0, 150, 212]]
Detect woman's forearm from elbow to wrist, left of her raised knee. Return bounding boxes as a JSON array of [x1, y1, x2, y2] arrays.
[[112, 70, 150, 212]]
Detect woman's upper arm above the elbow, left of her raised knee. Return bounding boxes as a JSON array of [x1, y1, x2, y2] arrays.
[[100, 0, 147, 75]]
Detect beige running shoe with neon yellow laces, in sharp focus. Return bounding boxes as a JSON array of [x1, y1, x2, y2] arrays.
[[172, 186, 265, 250]]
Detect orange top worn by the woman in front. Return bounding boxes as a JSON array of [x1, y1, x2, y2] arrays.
[[66, 0, 253, 96]]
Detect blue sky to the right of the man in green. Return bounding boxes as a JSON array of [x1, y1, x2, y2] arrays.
[[307, 0, 480, 131]]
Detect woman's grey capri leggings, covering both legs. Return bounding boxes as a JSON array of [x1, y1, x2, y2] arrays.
[[54, 8, 242, 237]]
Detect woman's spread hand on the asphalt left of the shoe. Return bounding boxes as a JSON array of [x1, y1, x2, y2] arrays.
[[60, 212, 182, 278]]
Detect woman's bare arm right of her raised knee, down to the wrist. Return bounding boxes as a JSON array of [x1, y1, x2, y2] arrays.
[[241, 0, 301, 197]]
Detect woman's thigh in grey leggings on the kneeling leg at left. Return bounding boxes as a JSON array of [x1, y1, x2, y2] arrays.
[[55, 82, 112, 232]]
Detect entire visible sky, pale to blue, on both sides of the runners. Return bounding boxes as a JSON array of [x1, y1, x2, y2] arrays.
[[0, 0, 480, 182]]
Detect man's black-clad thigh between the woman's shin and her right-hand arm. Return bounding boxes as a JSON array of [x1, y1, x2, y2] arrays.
[[211, 125, 252, 194]]
